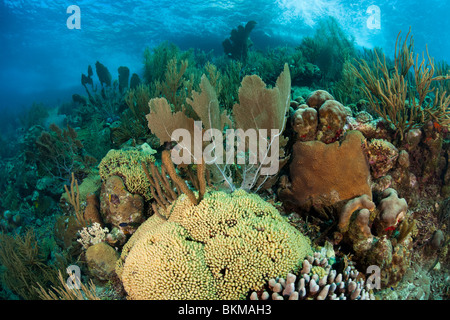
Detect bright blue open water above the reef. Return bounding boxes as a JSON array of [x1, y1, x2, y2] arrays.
[[0, 0, 450, 117]]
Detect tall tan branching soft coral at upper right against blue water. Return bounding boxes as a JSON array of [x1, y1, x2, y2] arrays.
[[353, 30, 450, 140]]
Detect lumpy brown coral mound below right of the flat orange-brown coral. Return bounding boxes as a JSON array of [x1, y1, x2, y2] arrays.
[[339, 188, 415, 288]]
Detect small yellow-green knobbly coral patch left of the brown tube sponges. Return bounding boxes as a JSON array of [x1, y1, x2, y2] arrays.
[[99, 149, 155, 200]]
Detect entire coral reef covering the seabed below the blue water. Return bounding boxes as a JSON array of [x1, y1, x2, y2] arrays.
[[0, 23, 450, 300]]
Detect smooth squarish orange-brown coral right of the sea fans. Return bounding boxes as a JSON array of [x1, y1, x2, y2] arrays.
[[279, 131, 372, 209]]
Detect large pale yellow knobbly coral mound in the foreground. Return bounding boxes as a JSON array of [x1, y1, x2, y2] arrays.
[[116, 190, 311, 299]]
